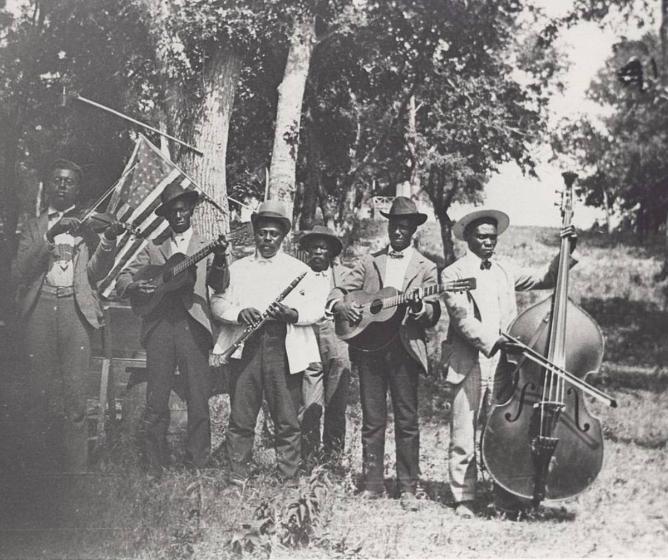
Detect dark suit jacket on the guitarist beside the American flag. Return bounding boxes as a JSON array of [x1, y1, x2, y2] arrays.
[[116, 230, 230, 346]]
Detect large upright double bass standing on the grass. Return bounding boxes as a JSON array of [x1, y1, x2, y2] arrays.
[[481, 173, 616, 506]]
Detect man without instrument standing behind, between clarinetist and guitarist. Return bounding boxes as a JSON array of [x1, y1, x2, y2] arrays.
[[299, 226, 350, 463]]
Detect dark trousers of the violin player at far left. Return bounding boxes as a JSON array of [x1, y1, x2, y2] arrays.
[[24, 293, 93, 472]]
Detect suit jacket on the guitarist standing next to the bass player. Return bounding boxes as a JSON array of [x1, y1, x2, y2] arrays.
[[328, 248, 441, 373]]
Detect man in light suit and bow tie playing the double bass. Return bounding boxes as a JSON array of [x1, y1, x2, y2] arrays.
[[441, 210, 577, 517]]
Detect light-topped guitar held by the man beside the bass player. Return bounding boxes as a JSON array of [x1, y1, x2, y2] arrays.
[[334, 278, 476, 352]]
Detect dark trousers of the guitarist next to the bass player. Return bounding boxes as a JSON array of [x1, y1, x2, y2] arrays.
[[359, 339, 420, 493]]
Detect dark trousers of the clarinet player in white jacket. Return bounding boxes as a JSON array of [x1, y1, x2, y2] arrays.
[[227, 323, 302, 479]]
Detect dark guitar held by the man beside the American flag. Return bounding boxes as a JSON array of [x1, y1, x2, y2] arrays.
[[130, 234, 225, 317]]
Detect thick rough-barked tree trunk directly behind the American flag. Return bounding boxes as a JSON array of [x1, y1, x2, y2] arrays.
[[182, 49, 241, 239]]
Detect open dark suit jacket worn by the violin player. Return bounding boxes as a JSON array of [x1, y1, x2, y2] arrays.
[[12, 212, 116, 329]]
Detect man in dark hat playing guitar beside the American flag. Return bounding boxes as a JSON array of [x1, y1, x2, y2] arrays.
[[116, 183, 229, 475]]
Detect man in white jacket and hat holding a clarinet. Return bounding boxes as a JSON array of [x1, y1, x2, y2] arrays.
[[211, 200, 323, 484]]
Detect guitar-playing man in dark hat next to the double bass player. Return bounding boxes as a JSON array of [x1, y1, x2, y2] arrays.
[[327, 196, 441, 511]]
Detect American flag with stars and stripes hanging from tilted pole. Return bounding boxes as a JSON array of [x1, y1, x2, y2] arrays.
[[98, 134, 192, 297]]
